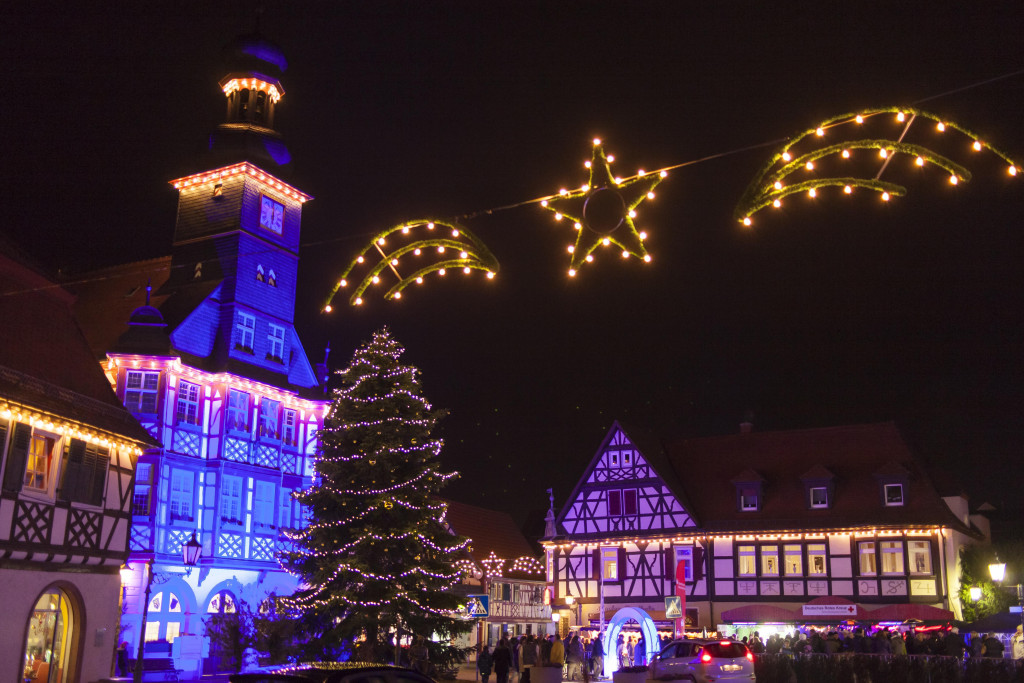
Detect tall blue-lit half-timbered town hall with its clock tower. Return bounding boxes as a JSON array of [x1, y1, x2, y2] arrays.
[[69, 34, 329, 671]]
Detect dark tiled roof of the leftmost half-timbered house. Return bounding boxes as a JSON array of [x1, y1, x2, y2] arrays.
[[0, 248, 156, 444]]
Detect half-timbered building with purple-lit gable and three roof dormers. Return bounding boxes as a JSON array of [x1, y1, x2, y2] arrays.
[[544, 423, 981, 675]]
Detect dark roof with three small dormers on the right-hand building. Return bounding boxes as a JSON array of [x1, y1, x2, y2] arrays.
[[668, 422, 974, 535]]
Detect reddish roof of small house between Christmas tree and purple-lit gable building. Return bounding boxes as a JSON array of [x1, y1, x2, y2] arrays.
[[445, 501, 541, 581]]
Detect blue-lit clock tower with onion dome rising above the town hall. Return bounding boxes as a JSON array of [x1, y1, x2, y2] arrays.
[[160, 33, 318, 388]]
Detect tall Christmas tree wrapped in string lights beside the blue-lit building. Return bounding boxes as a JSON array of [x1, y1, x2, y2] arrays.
[[282, 329, 470, 664]]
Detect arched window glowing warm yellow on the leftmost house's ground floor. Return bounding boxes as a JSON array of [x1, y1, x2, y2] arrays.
[[24, 589, 77, 683]]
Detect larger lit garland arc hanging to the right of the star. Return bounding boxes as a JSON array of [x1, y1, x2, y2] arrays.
[[733, 106, 1021, 225]]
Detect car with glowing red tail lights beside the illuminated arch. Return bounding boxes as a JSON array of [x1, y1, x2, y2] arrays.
[[650, 639, 755, 683]]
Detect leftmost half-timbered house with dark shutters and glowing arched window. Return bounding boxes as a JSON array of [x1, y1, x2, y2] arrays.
[[0, 245, 156, 683]]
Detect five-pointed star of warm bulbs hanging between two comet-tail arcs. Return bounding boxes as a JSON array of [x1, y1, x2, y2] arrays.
[[541, 139, 668, 276]]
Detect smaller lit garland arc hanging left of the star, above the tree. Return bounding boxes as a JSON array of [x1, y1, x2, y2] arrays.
[[324, 218, 499, 312]]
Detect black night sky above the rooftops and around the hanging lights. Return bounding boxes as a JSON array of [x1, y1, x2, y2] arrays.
[[0, 0, 1024, 518]]
